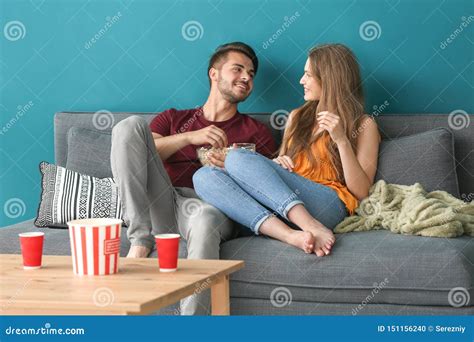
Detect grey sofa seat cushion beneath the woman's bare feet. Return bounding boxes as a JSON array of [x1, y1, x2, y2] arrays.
[[221, 231, 474, 307]]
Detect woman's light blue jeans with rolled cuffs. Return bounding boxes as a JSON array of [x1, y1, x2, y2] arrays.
[[193, 149, 347, 234]]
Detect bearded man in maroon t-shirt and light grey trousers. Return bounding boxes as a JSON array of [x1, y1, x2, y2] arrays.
[[111, 42, 276, 315]]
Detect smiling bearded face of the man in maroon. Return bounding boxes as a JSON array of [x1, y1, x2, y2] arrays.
[[212, 51, 255, 103]]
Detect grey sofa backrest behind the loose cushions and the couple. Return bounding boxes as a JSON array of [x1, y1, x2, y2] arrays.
[[54, 112, 474, 199]]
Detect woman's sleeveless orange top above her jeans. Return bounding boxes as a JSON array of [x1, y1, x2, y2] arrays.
[[293, 134, 359, 215]]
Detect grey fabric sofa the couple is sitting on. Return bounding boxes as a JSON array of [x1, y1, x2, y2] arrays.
[[0, 112, 474, 315]]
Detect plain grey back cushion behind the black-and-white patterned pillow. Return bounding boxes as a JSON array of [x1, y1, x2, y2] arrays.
[[66, 127, 112, 178]]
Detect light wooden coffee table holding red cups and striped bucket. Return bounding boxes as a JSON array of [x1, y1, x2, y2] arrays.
[[0, 254, 244, 315]]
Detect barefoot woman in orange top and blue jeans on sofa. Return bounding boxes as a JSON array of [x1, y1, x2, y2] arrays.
[[193, 44, 380, 256]]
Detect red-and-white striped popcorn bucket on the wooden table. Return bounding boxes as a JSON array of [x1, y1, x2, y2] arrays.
[[67, 218, 122, 275]]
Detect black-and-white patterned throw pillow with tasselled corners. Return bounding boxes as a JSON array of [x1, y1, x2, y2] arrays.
[[35, 162, 122, 228]]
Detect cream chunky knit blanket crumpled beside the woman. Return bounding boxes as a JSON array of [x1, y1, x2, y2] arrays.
[[334, 180, 474, 237]]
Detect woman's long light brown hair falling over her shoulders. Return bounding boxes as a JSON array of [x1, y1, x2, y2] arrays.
[[280, 44, 364, 184]]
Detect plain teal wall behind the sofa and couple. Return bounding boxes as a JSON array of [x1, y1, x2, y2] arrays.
[[0, 0, 474, 226]]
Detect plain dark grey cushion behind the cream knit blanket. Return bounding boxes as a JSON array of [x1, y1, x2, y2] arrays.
[[375, 128, 459, 198]]
